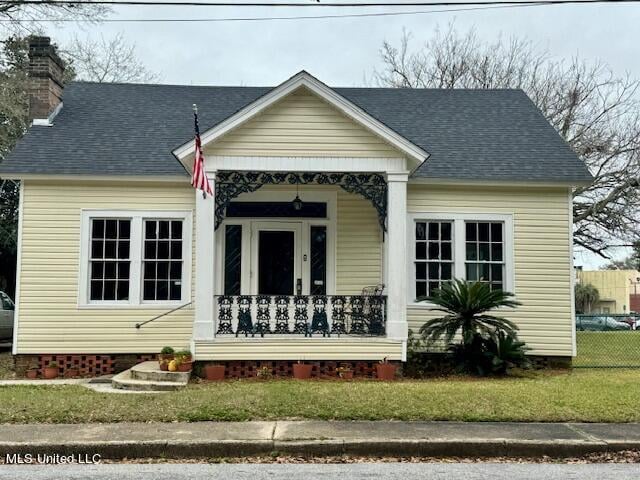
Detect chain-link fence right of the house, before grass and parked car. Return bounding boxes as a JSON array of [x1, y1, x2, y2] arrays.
[[573, 314, 640, 368]]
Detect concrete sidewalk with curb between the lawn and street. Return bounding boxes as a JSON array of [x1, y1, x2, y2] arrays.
[[0, 421, 640, 459]]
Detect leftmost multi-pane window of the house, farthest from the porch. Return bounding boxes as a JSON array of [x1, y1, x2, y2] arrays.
[[89, 218, 131, 301]]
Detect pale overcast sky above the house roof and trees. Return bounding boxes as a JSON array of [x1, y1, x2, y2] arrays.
[[36, 0, 640, 267]]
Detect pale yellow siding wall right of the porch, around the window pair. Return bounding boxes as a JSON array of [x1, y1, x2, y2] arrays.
[[408, 184, 573, 356]]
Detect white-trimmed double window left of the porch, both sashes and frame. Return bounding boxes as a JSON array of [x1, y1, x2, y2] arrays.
[[78, 210, 191, 306]]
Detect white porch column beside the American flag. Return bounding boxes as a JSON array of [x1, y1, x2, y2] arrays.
[[193, 172, 215, 340]]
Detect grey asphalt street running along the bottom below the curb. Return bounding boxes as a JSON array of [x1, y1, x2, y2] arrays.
[[0, 463, 640, 480]]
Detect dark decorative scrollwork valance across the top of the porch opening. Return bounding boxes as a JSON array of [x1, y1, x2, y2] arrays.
[[215, 170, 387, 232]]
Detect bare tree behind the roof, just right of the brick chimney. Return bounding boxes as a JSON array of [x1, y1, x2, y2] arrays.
[[63, 33, 158, 83]]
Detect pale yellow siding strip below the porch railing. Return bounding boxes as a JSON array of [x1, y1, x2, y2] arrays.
[[195, 338, 402, 360]]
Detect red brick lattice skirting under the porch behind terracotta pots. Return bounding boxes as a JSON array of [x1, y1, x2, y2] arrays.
[[196, 360, 401, 378]]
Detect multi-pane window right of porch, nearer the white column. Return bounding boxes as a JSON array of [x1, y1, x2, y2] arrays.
[[415, 221, 453, 298]]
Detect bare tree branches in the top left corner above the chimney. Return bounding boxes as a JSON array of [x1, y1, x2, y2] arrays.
[[0, 0, 110, 35]]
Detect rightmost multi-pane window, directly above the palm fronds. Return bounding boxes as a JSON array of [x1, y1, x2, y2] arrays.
[[465, 221, 505, 290]]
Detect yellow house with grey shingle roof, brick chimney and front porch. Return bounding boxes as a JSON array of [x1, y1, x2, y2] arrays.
[[0, 38, 591, 375]]
